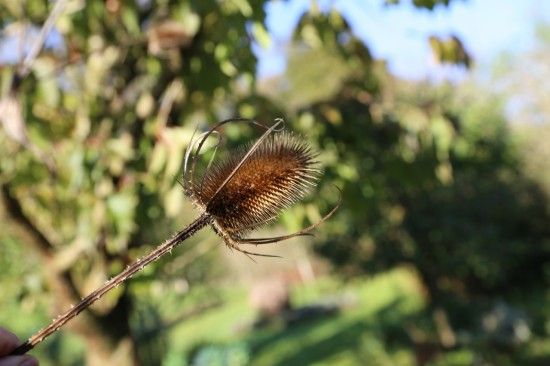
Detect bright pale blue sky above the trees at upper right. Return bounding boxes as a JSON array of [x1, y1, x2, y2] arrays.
[[258, 0, 550, 79]]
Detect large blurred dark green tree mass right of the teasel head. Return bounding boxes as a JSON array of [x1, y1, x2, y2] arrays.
[[264, 7, 550, 352]]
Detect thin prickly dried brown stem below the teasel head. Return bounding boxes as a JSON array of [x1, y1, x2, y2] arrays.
[[11, 213, 212, 355]]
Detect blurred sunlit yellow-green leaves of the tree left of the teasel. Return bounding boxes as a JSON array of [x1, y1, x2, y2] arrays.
[[0, 1, 265, 314]]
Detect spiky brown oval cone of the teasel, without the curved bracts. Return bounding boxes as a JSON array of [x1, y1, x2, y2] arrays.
[[191, 133, 320, 232]]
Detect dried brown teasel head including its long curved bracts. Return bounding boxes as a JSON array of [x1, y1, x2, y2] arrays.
[[184, 119, 336, 255]]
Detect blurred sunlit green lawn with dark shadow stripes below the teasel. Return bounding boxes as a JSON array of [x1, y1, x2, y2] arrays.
[[166, 268, 424, 365]]
